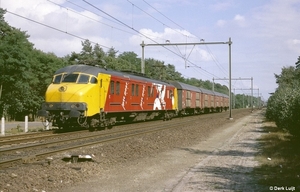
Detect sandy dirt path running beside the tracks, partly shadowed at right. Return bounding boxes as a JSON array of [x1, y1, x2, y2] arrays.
[[61, 111, 263, 192]]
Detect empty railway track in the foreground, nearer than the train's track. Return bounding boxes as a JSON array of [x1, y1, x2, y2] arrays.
[[0, 116, 203, 168]]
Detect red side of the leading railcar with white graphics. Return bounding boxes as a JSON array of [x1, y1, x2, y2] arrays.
[[105, 76, 176, 112]]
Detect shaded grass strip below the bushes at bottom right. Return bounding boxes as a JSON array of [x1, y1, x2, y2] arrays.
[[253, 122, 300, 190]]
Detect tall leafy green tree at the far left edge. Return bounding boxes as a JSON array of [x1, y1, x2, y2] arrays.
[[0, 10, 33, 118]]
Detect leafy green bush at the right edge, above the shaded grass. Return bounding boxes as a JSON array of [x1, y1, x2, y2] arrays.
[[266, 59, 300, 136]]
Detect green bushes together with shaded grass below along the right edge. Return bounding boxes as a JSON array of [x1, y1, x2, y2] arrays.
[[254, 57, 300, 191]]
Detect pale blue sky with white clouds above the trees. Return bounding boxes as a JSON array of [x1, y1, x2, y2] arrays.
[[0, 0, 300, 100]]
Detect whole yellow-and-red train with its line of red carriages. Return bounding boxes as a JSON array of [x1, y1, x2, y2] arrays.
[[38, 64, 229, 130]]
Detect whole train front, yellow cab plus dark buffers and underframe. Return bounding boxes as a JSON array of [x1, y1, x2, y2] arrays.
[[38, 69, 99, 128]]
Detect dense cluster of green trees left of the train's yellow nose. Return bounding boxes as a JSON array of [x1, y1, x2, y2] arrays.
[[0, 10, 64, 119]]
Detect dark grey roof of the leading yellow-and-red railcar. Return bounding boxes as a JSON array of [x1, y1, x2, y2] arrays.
[[54, 64, 172, 85]]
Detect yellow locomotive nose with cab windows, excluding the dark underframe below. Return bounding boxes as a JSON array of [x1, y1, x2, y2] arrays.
[[43, 74, 99, 117]]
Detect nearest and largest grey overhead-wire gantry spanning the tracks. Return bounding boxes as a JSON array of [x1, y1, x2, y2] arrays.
[[141, 37, 232, 120]]
